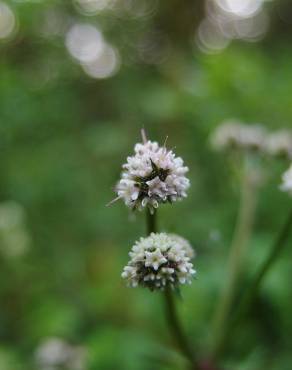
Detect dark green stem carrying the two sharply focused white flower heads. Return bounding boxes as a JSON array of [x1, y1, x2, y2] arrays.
[[147, 209, 198, 370]]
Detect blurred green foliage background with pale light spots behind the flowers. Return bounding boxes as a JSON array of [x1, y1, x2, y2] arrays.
[[0, 0, 292, 370]]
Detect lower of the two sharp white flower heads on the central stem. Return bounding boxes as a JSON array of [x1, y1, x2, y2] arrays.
[[122, 233, 196, 290]]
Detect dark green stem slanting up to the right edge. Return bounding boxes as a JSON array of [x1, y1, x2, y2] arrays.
[[222, 209, 292, 344]]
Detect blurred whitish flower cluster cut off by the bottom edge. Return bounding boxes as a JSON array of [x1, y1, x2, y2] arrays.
[[35, 338, 87, 370]]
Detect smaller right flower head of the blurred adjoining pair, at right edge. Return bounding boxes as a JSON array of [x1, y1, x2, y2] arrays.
[[265, 130, 292, 159]]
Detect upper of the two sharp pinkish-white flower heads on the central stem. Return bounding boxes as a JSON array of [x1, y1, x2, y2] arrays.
[[116, 141, 190, 212]]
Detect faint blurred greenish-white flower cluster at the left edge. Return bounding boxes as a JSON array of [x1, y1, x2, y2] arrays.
[[0, 201, 31, 257]]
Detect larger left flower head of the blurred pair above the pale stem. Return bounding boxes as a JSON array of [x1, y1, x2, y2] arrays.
[[211, 120, 265, 150]]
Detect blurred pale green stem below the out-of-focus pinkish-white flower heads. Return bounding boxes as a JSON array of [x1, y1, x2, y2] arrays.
[[213, 158, 258, 358]]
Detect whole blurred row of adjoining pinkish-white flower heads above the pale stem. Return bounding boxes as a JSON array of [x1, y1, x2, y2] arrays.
[[211, 120, 292, 159]]
